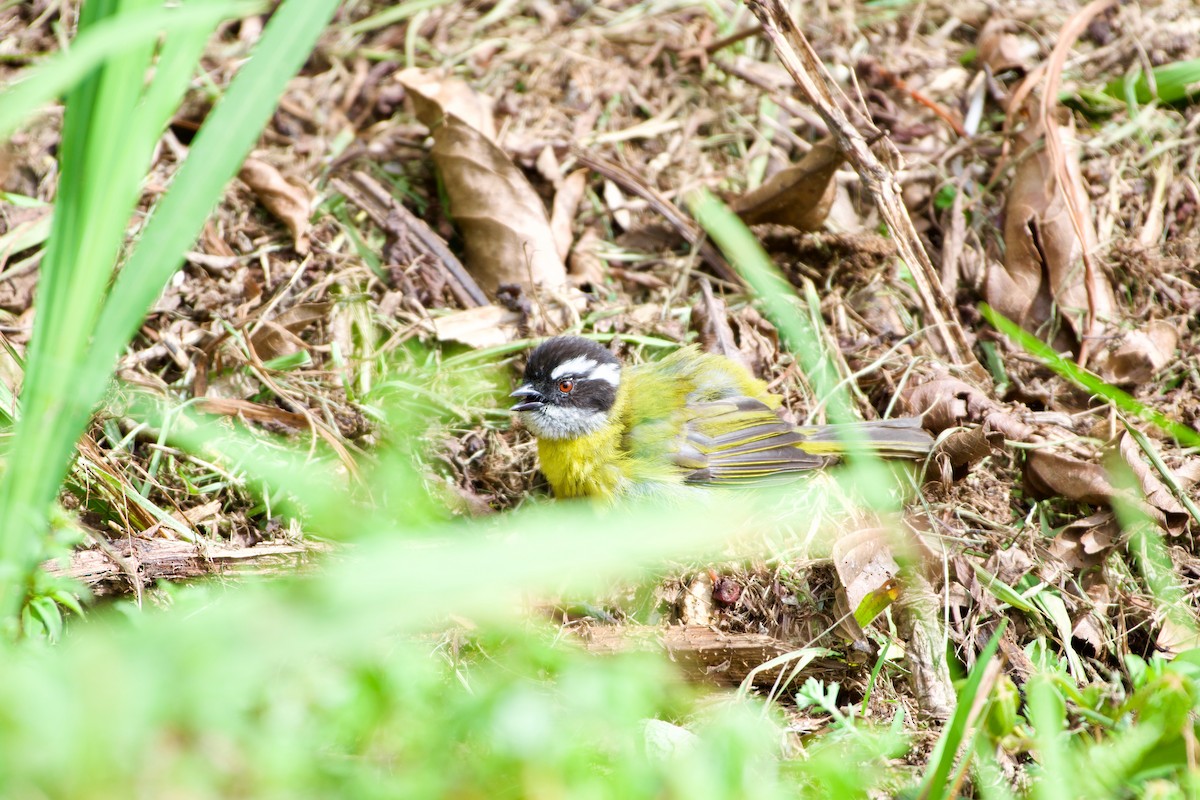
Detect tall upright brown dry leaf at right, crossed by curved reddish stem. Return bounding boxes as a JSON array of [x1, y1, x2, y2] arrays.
[[984, 98, 1116, 351]]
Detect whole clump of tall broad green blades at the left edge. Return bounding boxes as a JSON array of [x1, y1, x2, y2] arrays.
[[0, 0, 336, 633]]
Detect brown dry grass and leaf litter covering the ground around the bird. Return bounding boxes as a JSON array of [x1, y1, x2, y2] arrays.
[[0, 0, 1200, 777]]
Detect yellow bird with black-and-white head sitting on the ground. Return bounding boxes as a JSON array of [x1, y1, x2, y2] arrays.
[[511, 336, 935, 501]]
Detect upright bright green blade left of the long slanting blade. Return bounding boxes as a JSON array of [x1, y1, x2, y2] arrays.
[[0, 0, 229, 621]]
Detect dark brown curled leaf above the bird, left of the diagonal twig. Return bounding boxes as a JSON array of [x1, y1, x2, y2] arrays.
[[730, 138, 845, 230]]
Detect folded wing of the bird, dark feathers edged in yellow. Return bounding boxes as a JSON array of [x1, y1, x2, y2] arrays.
[[674, 397, 827, 483]]
